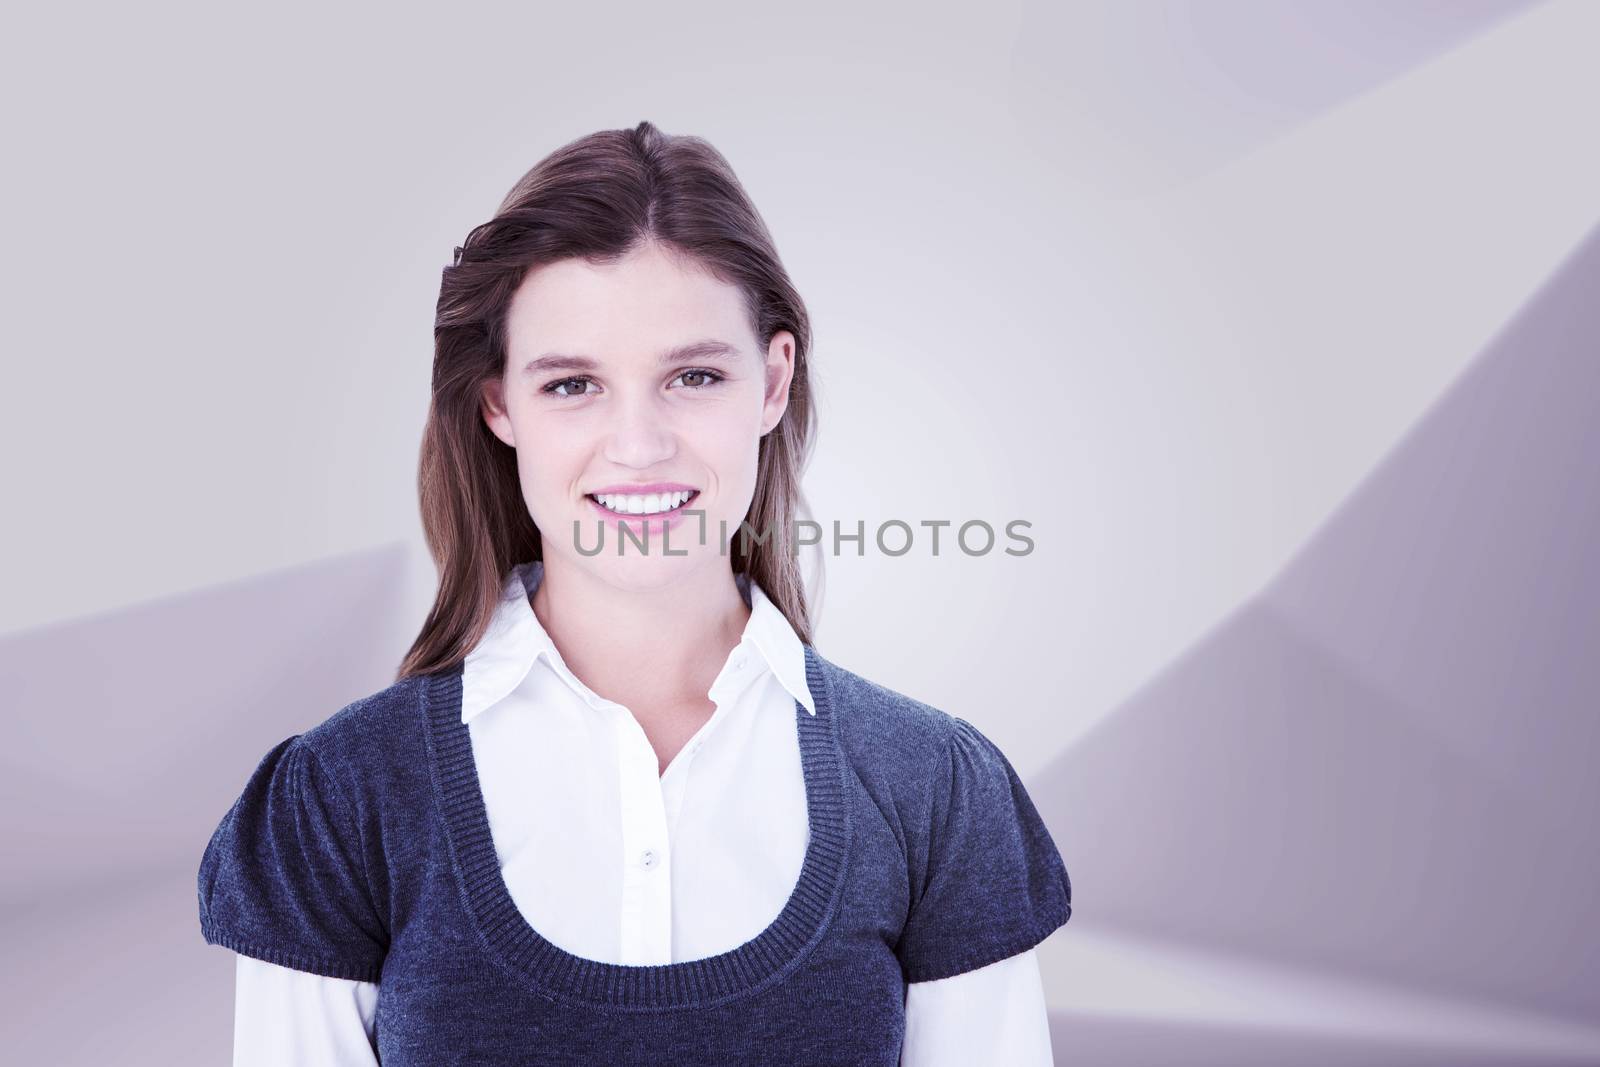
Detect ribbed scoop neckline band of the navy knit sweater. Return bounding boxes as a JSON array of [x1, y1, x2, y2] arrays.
[[422, 645, 851, 1011]]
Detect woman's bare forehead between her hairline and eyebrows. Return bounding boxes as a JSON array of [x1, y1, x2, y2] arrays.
[[506, 245, 750, 360]]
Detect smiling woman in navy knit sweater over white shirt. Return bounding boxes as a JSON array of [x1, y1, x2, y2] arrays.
[[198, 123, 1072, 1067]]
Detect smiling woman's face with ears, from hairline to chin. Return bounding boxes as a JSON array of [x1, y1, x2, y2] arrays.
[[483, 243, 794, 587]]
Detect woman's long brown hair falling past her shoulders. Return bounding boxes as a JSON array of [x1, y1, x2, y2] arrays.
[[398, 122, 816, 678]]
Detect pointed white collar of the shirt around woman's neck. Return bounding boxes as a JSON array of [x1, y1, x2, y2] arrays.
[[461, 560, 816, 723]]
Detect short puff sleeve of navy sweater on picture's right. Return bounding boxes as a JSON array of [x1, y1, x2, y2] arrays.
[[894, 715, 1072, 982]]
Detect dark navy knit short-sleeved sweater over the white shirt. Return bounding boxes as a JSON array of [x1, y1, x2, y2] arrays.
[[198, 645, 1072, 1067]]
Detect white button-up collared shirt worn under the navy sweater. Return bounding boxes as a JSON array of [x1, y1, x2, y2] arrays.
[[234, 561, 1051, 1067]]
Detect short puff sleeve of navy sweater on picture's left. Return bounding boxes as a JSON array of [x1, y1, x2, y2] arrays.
[[200, 734, 389, 982]]
